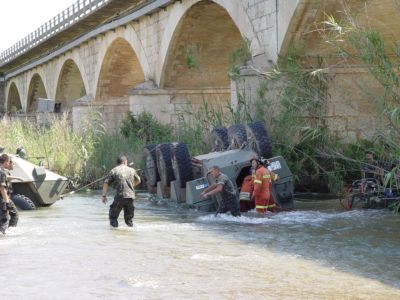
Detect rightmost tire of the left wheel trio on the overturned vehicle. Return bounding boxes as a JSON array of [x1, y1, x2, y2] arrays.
[[172, 143, 193, 188]]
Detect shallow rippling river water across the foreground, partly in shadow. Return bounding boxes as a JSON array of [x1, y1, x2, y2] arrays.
[[0, 194, 400, 299]]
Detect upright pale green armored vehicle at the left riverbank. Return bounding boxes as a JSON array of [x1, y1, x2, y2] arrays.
[[10, 155, 68, 210]]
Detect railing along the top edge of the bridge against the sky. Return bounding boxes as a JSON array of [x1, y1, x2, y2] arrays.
[[0, 0, 112, 66]]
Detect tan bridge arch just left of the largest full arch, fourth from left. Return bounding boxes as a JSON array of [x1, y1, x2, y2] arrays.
[[95, 35, 149, 103]]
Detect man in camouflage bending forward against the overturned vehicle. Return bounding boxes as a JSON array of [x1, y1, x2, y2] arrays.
[[200, 166, 240, 217]]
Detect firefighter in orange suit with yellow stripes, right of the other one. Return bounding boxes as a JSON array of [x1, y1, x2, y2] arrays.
[[250, 157, 279, 214]]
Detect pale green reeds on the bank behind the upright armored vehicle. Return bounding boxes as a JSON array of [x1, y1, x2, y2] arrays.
[[0, 115, 142, 184]]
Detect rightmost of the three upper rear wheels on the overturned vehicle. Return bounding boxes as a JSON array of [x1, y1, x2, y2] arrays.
[[246, 122, 272, 158]]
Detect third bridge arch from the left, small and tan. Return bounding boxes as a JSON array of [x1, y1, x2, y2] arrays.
[[54, 58, 87, 112]]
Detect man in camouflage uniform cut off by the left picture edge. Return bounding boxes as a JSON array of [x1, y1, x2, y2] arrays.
[[0, 153, 18, 234]]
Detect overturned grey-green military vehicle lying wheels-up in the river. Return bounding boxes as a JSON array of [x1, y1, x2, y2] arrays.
[[143, 122, 294, 212]]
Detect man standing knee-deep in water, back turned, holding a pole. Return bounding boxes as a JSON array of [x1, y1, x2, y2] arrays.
[[102, 155, 141, 228]]
